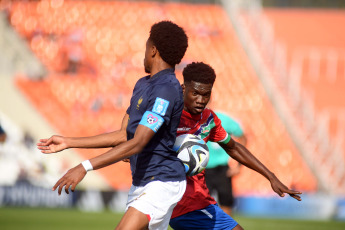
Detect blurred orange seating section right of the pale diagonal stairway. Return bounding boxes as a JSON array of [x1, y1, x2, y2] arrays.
[[237, 8, 345, 194]]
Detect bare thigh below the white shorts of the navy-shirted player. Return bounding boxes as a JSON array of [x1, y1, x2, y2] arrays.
[[115, 207, 149, 230]]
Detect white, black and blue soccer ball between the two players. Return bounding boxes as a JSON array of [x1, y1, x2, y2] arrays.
[[173, 134, 210, 176]]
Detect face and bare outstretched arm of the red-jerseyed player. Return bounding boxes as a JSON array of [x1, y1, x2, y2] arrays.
[[182, 81, 302, 201]]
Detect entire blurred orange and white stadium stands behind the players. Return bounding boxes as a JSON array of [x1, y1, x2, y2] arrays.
[[0, 0, 345, 219]]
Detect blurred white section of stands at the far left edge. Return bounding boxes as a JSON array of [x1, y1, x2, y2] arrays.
[[0, 117, 61, 187]]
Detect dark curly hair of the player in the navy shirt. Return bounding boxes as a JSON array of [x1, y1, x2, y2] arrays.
[[149, 21, 188, 66]]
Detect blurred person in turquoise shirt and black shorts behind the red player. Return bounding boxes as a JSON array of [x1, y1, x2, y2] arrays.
[[205, 112, 247, 215]]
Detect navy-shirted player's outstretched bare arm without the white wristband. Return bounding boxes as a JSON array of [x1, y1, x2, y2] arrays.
[[37, 114, 128, 154]]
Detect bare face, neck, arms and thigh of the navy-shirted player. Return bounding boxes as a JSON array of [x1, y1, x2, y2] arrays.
[[37, 39, 174, 230]]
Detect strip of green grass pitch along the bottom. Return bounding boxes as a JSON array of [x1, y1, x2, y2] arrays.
[[0, 207, 345, 230]]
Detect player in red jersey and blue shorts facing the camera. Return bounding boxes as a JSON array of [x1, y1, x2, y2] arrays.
[[170, 62, 301, 230]]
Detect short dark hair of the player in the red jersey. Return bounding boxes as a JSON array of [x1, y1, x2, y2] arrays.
[[182, 62, 216, 85]]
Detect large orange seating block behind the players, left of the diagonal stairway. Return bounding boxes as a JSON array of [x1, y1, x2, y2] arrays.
[[6, 1, 317, 195]]
